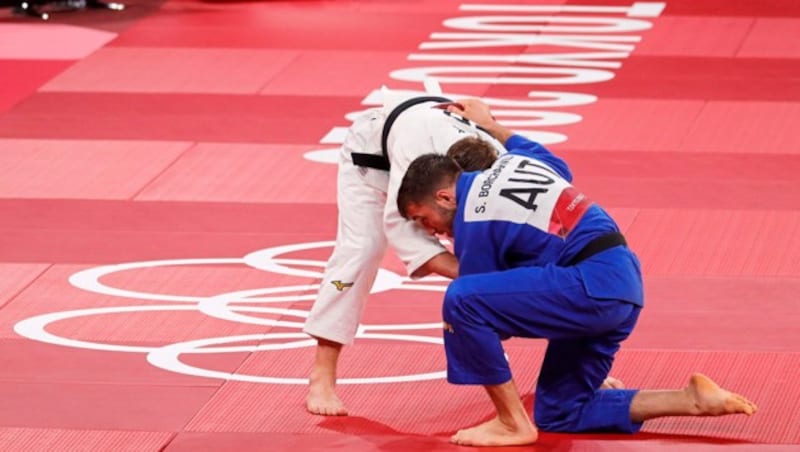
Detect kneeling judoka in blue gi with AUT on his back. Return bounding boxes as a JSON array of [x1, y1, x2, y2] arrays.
[[397, 99, 756, 446]]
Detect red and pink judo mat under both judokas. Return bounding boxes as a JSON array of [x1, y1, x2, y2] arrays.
[[0, 0, 800, 452]]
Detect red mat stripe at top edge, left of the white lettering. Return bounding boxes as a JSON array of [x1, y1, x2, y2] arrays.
[[111, 0, 450, 51]]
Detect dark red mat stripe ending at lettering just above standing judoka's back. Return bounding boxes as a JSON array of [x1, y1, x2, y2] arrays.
[[0, 93, 356, 144]]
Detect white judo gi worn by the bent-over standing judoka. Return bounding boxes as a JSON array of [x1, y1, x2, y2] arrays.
[[303, 96, 505, 344]]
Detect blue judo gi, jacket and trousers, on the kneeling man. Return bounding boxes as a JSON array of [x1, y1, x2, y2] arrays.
[[443, 135, 644, 433]]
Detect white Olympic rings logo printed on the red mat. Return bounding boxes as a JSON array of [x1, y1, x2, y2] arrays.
[[14, 242, 447, 384]]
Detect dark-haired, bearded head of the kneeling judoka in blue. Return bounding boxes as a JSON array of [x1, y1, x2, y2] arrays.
[[397, 154, 461, 236]]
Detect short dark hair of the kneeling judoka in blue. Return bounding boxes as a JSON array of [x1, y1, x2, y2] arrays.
[[397, 154, 461, 219]]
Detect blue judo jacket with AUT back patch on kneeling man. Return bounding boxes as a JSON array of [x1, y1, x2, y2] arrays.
[[453, 135, 643, 306]]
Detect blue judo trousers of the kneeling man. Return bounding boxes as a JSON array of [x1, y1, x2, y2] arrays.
[[443, 252, 641, 433]]
